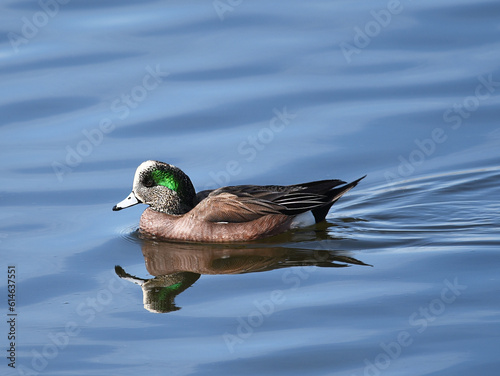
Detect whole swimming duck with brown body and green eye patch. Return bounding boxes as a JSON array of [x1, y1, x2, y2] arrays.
[[113, 160, 366, 243]]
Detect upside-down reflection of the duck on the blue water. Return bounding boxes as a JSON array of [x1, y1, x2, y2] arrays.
[[115, 239, 369, 313]]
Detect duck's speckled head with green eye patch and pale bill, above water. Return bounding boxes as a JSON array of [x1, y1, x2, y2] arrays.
[[113, 161, 196, 215]]
